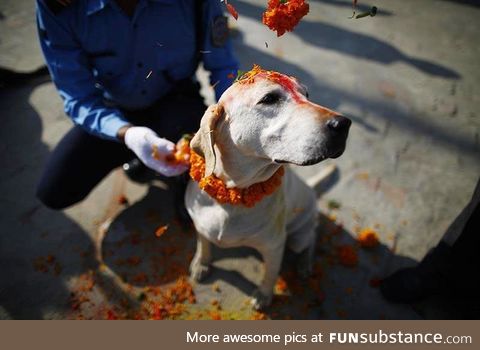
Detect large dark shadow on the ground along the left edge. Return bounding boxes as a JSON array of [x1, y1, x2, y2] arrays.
[[0, 72, 139, 319]]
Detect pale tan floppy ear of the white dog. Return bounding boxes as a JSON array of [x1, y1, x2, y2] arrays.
[[190, 104, 224, 176]]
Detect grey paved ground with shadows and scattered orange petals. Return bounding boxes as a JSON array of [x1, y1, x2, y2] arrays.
[[0, 0, 480, 319]]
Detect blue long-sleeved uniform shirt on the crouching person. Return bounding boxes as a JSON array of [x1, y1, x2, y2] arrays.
[[37, 0, 238, 140]]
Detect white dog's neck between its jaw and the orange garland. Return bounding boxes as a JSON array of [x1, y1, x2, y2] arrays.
[[214, 130, 281, 188]]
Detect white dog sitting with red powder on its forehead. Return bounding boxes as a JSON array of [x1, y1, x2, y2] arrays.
[[185, 68, 351, 309]]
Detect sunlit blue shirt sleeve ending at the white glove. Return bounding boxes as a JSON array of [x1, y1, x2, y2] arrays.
[[37, 1, 129, 141]]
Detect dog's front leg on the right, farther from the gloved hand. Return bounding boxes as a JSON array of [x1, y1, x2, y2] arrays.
[[252, 240, 285, 310]]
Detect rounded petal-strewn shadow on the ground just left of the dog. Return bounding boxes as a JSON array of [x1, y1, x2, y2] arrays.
[[102, 186, 195, 287]]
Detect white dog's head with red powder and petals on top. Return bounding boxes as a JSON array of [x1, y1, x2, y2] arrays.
[[191, 67, 351, 178]]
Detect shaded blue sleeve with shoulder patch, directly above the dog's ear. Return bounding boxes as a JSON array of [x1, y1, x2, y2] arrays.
[[202, 0, 238, 100]]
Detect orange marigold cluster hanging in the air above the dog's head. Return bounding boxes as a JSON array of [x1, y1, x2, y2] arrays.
[[262, 0, 310, 36]]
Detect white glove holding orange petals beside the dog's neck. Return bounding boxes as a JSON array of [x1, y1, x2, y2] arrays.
[[125, 126, 188, 176]]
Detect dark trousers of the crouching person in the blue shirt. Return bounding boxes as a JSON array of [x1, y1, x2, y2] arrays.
[[37, 80, 206, 209]]
